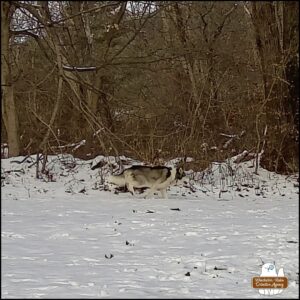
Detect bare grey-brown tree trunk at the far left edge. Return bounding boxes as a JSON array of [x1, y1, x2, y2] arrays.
[[1, 1, 20, 157]]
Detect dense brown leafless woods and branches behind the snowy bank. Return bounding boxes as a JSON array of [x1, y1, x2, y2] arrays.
[[1, 1, 299, 173]]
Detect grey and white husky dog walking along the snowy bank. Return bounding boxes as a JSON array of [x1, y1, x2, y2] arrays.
[[107, 166, 185, 198]]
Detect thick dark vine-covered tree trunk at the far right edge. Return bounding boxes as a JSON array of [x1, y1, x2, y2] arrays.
[[252, 1, 299, 173]]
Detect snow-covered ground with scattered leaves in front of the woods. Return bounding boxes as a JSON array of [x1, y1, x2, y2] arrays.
[[1, 156, 299, 298]]
